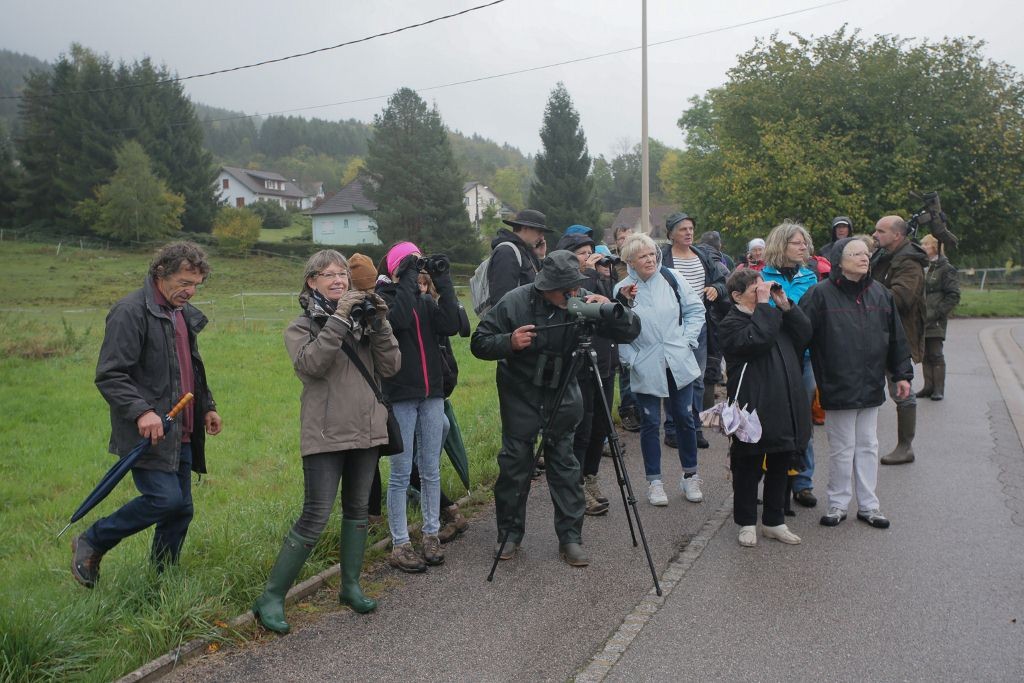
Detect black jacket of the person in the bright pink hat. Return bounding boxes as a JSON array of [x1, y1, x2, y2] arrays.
[[377, 270, 459, 402]]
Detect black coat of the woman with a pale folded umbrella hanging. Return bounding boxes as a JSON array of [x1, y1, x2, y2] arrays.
[[718, 303, 811, 456]]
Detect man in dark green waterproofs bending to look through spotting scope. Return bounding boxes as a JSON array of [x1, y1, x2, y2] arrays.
[[470, 251, 640, 566]]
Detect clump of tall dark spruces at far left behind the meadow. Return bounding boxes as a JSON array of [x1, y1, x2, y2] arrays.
[[17, 45, 216, 231]]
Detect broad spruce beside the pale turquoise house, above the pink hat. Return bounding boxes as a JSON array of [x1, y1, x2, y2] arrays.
[[367, 88, 480, 262]]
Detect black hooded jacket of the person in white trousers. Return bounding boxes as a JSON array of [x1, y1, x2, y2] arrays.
[[800, 267, 913, 411]]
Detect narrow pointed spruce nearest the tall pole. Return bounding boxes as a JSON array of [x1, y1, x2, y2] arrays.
[[529, 82, 600, 235]]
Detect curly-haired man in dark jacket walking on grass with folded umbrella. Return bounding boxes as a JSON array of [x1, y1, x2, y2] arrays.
[[72, 242, 221, 588]]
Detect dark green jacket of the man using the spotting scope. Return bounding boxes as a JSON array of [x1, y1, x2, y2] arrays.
[[470, 284, 640, 439]]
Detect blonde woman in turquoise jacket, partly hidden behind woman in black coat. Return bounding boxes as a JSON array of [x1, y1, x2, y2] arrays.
[[761, 221, 818, 508]]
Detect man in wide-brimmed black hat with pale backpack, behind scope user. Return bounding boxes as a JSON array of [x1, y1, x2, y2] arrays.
[[487, 209, 554, 306]]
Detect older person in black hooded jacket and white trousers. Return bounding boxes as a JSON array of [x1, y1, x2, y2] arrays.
[[800, 238, 913, 528]]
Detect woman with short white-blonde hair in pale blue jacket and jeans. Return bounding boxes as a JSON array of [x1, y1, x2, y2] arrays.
[[614, 233, 705, 506]]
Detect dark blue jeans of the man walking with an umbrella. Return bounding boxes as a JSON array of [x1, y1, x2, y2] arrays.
[[85, 443, 194, 566]]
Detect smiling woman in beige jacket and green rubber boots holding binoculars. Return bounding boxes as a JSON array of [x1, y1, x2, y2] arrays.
[[253, 249, 400, 634]]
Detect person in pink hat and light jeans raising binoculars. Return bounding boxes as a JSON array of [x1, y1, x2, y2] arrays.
[[376, 242, 460, 572]]
